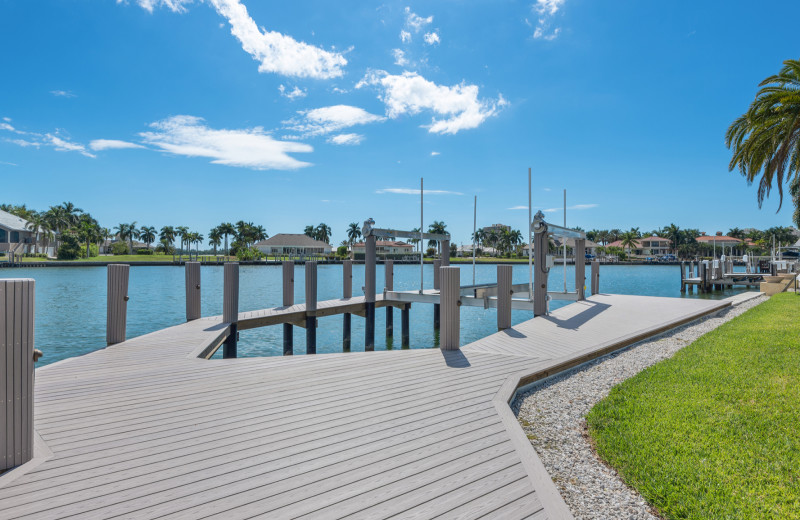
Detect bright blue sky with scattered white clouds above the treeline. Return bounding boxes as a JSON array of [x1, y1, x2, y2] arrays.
[[0, 0, 800, 243]]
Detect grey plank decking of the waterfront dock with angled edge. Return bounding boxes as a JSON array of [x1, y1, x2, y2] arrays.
[[0, 295, 729, 519]]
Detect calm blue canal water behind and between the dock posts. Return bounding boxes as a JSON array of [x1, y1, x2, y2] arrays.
[[0, 265, 752, 364]]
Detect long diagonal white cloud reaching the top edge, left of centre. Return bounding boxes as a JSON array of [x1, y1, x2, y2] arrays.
[[208, 0, 347, 79]]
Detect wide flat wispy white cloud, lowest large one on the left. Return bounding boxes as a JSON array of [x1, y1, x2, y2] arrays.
[[140, 116, 313, 170]]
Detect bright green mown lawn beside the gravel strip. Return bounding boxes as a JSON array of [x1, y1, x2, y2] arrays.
[[586, 293, 800, 519]]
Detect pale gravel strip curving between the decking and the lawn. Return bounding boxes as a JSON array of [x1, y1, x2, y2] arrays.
[[512, 296, 767, 519]]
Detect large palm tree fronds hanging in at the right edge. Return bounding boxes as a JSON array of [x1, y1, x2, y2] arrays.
[[725, 60, 800, 211]]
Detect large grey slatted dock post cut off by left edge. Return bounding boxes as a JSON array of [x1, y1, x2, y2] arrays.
[[0, 278, 35, 472]]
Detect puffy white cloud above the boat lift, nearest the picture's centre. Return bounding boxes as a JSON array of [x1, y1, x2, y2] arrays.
[[356, 71, 508, 134]]
